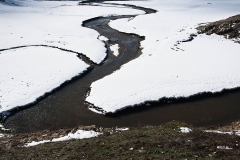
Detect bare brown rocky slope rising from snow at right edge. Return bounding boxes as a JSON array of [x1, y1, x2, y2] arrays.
[[197, 14, 240, 43]]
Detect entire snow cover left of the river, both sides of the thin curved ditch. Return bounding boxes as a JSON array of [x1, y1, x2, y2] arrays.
[[0, 0, 143, 115]]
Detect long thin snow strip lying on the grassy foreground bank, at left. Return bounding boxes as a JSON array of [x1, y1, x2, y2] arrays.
[[24, 130, 102, 147]]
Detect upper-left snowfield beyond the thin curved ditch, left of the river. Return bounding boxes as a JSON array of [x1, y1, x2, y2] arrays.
[[0, 0, 143, 63]]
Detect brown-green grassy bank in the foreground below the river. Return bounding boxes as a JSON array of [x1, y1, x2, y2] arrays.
[[0, 121, 240, 160]]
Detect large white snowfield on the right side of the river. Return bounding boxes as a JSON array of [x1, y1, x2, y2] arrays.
[[86, 0, 240, 113]]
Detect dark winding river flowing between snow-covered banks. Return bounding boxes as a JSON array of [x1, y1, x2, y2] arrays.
[[5, 2, 240, 132]]
